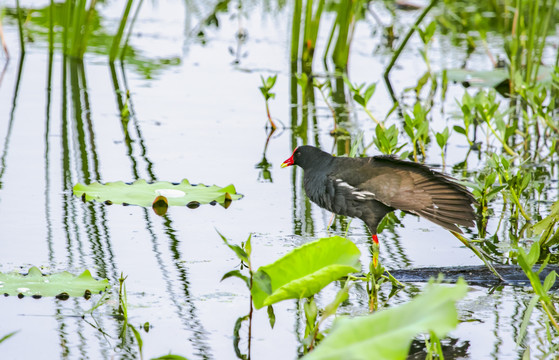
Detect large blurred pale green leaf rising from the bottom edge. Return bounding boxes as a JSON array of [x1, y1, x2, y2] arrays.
[[303, 279, 468, 360]]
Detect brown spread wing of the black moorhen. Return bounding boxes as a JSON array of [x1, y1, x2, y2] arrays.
[[334, 156, 476, 233]]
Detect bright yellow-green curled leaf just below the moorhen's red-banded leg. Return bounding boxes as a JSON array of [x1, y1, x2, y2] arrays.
[[252, 236, 361, 309]]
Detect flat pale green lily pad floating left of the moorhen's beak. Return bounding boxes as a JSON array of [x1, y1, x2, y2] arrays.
[[74, 179, 242, 208]]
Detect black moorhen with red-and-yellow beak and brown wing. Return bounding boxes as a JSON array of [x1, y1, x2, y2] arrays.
[[281, 146, 476, 244]]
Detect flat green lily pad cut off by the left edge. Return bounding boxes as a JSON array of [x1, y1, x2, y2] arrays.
[[0, 266, 109, 299]]
